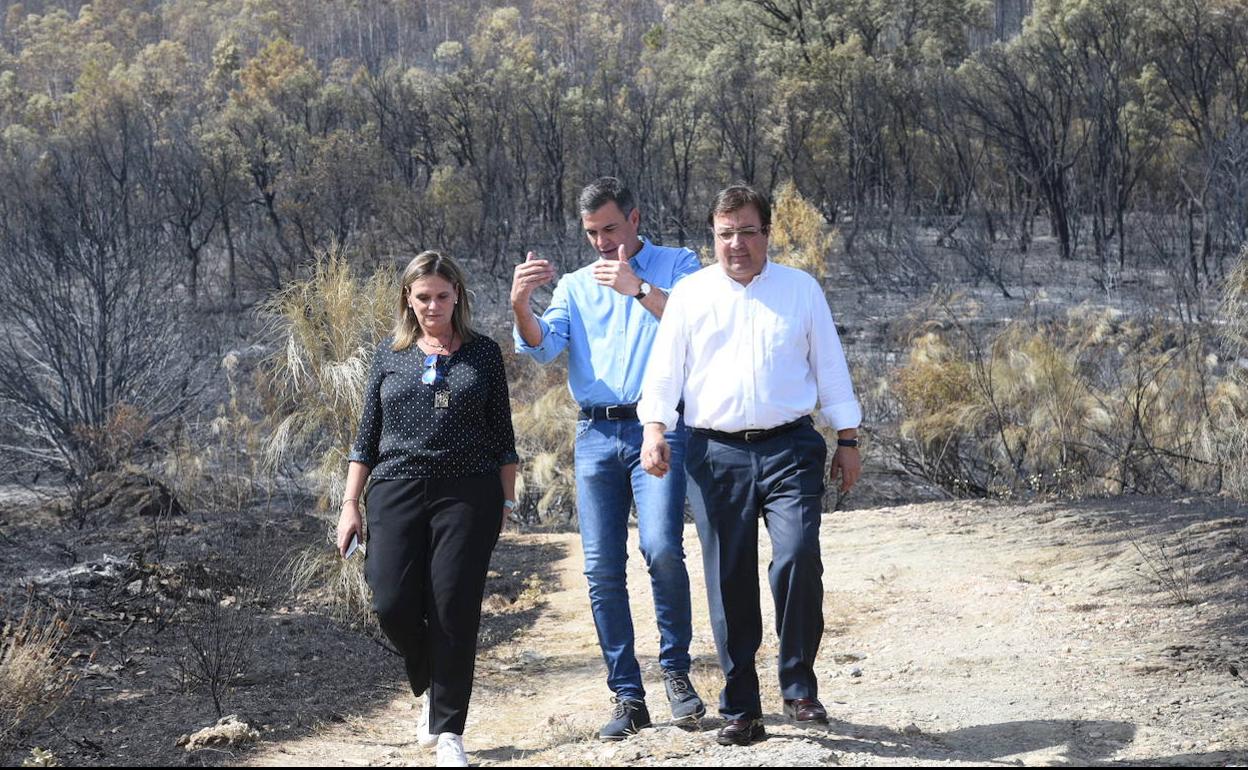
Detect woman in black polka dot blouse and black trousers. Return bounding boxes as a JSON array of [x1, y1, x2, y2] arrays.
[[338, 251, 518, 764]]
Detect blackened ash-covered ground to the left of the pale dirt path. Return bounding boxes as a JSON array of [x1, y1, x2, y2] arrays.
[[0, 489, 564, 766]]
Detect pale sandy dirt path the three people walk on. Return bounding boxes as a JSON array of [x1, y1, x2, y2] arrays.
[[238, 500, 1248, 765]]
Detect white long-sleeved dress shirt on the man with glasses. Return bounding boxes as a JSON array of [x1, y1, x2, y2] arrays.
[[636, 260, 862, 433]]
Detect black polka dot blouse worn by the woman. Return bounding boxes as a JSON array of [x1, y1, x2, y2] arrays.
[[348, 334, 518, 478]]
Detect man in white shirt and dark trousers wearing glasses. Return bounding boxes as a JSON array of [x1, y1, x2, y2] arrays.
[[638, 185, 862, 745]]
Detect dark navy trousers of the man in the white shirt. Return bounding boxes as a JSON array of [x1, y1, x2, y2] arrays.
[[685, 424, 827, 719]]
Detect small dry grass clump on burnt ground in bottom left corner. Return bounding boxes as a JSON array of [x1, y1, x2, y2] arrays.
[[0, 600, 77, 756]]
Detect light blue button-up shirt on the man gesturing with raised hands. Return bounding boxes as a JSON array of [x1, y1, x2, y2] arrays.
[[512, 238, 701, 407]]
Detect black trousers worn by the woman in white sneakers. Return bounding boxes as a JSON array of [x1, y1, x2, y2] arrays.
[[364, 473, 503, 735]]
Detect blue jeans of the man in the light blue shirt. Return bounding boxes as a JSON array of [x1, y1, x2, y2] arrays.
[[577, 419, 693, 700]]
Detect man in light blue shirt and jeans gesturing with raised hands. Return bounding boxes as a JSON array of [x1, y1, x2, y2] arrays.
[[512, 177, 706, 740]]
